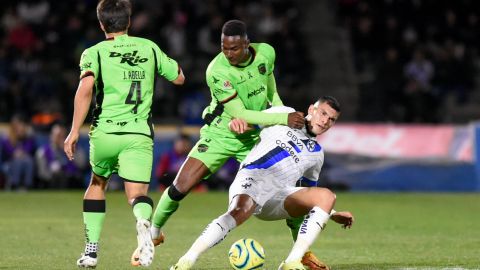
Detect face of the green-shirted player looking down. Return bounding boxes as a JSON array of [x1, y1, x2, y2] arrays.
[[221, 34, 250, 66]]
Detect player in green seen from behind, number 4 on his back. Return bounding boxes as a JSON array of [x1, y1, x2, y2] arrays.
[[64, 0, 185, 268]]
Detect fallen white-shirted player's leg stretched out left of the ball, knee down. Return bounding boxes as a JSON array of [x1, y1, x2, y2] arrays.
[[171, 194, 256, 270]]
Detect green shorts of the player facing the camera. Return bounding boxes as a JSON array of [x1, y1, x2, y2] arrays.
[[188, 132, 259, 179]]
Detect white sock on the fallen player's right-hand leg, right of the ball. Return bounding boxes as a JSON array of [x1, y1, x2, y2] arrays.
[[285, 206, 330, 262]]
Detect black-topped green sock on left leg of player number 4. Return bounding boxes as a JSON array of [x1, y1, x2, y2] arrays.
[[83, 200, 105, 243]]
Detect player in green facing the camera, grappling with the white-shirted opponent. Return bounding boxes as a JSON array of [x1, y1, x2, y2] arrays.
[[141, 20, 314, 266]]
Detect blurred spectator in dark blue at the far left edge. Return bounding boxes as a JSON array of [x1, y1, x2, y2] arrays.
[[0, 115, 36, 190]]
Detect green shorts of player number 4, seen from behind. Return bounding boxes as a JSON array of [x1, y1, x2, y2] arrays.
[[90, 129, 153, 183]]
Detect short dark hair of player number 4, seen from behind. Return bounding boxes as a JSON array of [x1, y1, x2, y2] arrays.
[[97, 0, 132, 33]]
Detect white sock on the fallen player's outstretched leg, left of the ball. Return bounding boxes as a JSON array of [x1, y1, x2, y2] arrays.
[[182, 213, 237, 262]]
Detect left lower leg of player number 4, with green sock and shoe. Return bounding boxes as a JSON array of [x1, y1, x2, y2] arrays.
[[77, 173, 107, 267]]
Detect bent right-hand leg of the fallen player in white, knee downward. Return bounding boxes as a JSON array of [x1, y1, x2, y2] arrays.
[[284, 187, 335, 269]]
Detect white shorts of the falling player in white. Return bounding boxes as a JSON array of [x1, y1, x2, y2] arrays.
[[228, 170, 304, 220]]
